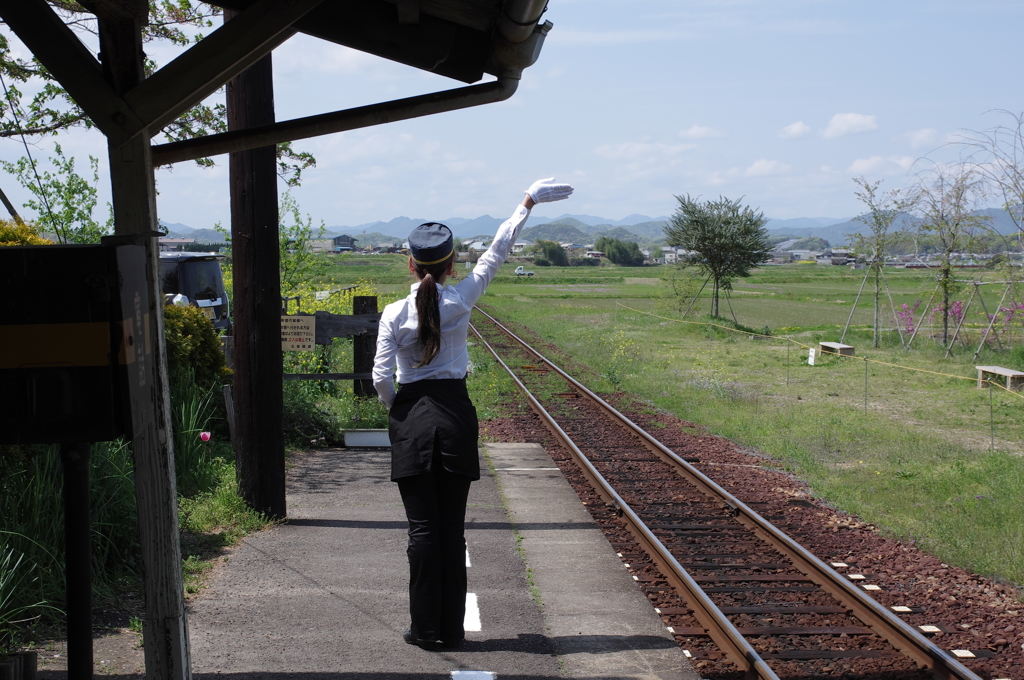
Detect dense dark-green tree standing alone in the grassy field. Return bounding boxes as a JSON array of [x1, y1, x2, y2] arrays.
[[665, 195, 771, 316]]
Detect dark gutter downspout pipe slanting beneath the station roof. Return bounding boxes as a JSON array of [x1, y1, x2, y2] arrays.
[[153, 19, 552, 166]]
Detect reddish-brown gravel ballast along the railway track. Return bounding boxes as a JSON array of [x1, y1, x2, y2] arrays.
[[481, 387, 1024, 680]]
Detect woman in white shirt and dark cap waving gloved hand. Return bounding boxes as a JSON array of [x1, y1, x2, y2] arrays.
[[373, 178, 572, 649]]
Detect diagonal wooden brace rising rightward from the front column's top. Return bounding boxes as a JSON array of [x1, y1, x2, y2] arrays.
[[125, 0, 323, 134]]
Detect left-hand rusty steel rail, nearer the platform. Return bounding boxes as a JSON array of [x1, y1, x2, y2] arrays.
[[470, 325, 779, 680]]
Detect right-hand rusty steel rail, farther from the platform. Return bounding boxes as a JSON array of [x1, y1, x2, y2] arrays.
[[474, 307, 981, 680]]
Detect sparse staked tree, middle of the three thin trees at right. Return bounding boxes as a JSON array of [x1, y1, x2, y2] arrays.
[[913, 163, 988, 344]]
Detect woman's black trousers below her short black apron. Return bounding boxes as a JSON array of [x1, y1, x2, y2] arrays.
[[395, 465, 472, 644]]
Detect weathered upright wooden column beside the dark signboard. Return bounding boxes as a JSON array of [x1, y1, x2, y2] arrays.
[[99, 6, 191, 680]]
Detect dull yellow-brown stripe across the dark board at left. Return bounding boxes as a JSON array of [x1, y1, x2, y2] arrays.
[[0, 322, 111, 369]]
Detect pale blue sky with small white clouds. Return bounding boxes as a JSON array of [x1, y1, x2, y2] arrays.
[[0, 0, 1024, 227]]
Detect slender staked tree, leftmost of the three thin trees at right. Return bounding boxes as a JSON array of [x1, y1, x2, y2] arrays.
[[851, 177, 913, 347]]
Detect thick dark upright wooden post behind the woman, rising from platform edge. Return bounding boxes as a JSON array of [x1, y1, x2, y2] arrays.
[[224, 10, 287, 517]]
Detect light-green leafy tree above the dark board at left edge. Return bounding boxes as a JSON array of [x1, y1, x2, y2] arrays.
[[0, 144, 112, 244]]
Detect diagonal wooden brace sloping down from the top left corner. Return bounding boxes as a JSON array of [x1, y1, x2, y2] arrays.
[[0, 0, 144, 143]]
